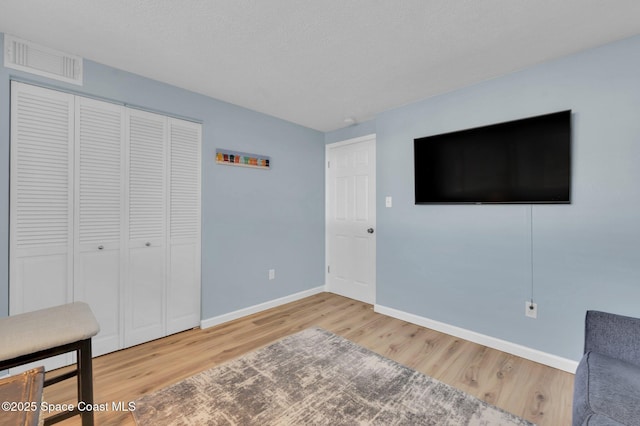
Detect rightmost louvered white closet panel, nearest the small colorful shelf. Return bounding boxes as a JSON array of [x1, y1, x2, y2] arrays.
[[167, 119, 202, 334]]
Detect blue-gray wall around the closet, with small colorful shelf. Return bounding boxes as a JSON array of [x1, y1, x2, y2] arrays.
[[0, 34, 324, 319]]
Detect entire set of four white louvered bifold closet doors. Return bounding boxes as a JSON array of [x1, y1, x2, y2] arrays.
[[9, 82, 202, 364]]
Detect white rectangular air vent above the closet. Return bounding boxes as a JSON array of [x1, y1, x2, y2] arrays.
[[4, 34, 82, 85]]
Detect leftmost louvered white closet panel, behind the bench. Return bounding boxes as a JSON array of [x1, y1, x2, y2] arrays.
[[9, 82, 74, 372]]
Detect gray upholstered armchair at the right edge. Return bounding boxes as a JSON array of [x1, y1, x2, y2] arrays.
[[573, 311, 640, 426]]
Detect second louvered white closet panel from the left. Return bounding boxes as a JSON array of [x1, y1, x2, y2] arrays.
[[74, 97, 126, 356]]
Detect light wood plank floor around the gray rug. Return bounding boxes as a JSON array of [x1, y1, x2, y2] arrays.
[[44, 293, 573, 426]]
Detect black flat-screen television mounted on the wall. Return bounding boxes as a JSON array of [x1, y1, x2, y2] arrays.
[[413, 110, 571, 204]]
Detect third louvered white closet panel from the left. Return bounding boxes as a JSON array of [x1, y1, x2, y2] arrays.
[[124, 110, 168, 346]]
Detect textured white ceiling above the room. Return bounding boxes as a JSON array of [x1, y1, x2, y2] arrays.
[[0, 0, 640, 131]]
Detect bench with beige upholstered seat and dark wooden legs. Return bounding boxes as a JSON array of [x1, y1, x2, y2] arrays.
[[0, 302, 100, 426]]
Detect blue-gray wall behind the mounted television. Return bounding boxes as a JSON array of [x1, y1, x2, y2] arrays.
[[325, 33, 640, 360]]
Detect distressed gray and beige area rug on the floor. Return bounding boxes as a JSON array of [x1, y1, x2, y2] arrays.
[[133, 328, 532, 426]]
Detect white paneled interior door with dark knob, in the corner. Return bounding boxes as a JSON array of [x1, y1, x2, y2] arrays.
[[326, 135, 376, 303]]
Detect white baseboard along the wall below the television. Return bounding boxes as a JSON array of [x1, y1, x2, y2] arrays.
[[374, 305, 578, 374]]
